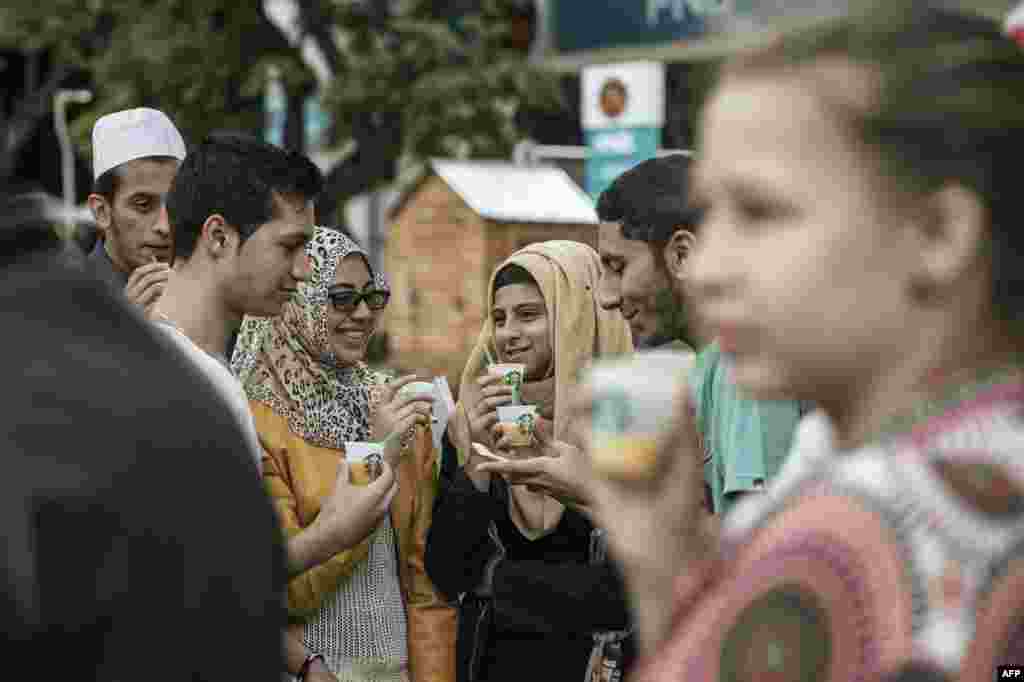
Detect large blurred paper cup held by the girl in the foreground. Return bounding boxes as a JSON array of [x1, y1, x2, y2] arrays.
[[587, 351, 692, 480]]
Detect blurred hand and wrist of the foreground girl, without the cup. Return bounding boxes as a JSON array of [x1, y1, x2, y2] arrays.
[[573, 378, 716, 650]]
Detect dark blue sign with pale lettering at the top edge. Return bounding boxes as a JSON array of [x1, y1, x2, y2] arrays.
[[551, 0, 723, 52]]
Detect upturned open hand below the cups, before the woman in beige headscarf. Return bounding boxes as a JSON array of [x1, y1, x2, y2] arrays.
[[479, 419, 592, 507]]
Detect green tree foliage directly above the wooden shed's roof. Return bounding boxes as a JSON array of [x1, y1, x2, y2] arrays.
[[326, 0, 561, 173]]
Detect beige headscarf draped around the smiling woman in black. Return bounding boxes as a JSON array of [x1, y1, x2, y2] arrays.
[[450, 241, 633, 540]]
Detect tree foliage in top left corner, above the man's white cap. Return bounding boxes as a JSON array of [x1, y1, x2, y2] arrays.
[[0, 0, 301, 161]]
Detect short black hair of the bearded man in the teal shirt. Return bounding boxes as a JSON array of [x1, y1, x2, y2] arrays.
[[597, 154, 700, 249]]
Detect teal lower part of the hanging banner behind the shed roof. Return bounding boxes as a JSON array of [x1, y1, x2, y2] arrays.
[[585, 127, 662, 201]]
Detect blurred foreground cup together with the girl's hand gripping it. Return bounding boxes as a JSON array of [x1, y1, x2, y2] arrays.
[[572, 353, 708, 576]]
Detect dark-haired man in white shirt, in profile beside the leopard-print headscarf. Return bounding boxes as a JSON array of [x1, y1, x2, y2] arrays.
[[150, 134, 395, 679]]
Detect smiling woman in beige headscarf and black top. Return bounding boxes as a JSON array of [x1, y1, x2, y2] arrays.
[[426, 241, 633, 682]]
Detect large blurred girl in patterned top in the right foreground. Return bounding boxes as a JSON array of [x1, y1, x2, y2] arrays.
[[595, 0, 1024, 681]]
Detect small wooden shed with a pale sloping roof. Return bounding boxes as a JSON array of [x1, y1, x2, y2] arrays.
[[384, 161, 597, 391]]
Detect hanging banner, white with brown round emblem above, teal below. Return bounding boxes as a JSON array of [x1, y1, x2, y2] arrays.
[[580, 61, 665, 200]]
